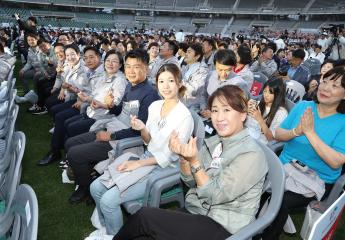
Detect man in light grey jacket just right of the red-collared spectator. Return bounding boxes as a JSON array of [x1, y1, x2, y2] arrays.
[[250, 47, 278, 77]]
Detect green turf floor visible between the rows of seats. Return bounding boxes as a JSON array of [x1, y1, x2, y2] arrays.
[[15, 60, 345, 240]]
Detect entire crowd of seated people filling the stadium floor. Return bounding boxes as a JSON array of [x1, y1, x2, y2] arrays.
[[0, 25, 345, 240]]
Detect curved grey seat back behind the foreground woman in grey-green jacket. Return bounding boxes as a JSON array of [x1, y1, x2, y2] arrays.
[[227, 141, 285, 240]]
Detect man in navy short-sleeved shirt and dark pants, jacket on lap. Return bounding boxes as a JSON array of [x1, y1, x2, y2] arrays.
[[65, 49, 159, 203]]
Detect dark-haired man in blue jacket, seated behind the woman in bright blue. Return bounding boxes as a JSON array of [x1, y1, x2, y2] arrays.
[[287, 49, 310, 86]]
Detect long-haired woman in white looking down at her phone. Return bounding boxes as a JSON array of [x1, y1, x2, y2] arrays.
[[246, 77, 288, 144]]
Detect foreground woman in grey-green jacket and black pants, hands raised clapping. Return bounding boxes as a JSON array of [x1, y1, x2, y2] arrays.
[[114, 85, 268, 240]]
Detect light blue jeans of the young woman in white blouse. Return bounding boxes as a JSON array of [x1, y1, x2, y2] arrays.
[[90, 174, 150, 235]]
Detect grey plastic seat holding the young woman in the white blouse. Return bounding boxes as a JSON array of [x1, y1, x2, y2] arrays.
[[123, 111, 205, 214]]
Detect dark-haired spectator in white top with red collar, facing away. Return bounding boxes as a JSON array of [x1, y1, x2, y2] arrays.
[[234, 44, 254, 89]]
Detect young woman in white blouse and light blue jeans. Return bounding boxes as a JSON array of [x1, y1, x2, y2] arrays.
[[87, 64, 194, 240]]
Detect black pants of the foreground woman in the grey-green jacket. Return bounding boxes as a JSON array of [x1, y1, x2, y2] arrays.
[[113, 208, 231, 240]]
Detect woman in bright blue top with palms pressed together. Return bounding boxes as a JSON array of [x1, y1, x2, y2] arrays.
[[263, 67, 345, 239]]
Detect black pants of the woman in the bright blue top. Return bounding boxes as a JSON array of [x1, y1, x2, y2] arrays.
[[261, 184, 333, 240]]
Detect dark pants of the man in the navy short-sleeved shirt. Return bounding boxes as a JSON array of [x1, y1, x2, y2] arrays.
[[65, 132, 112, 187]]
